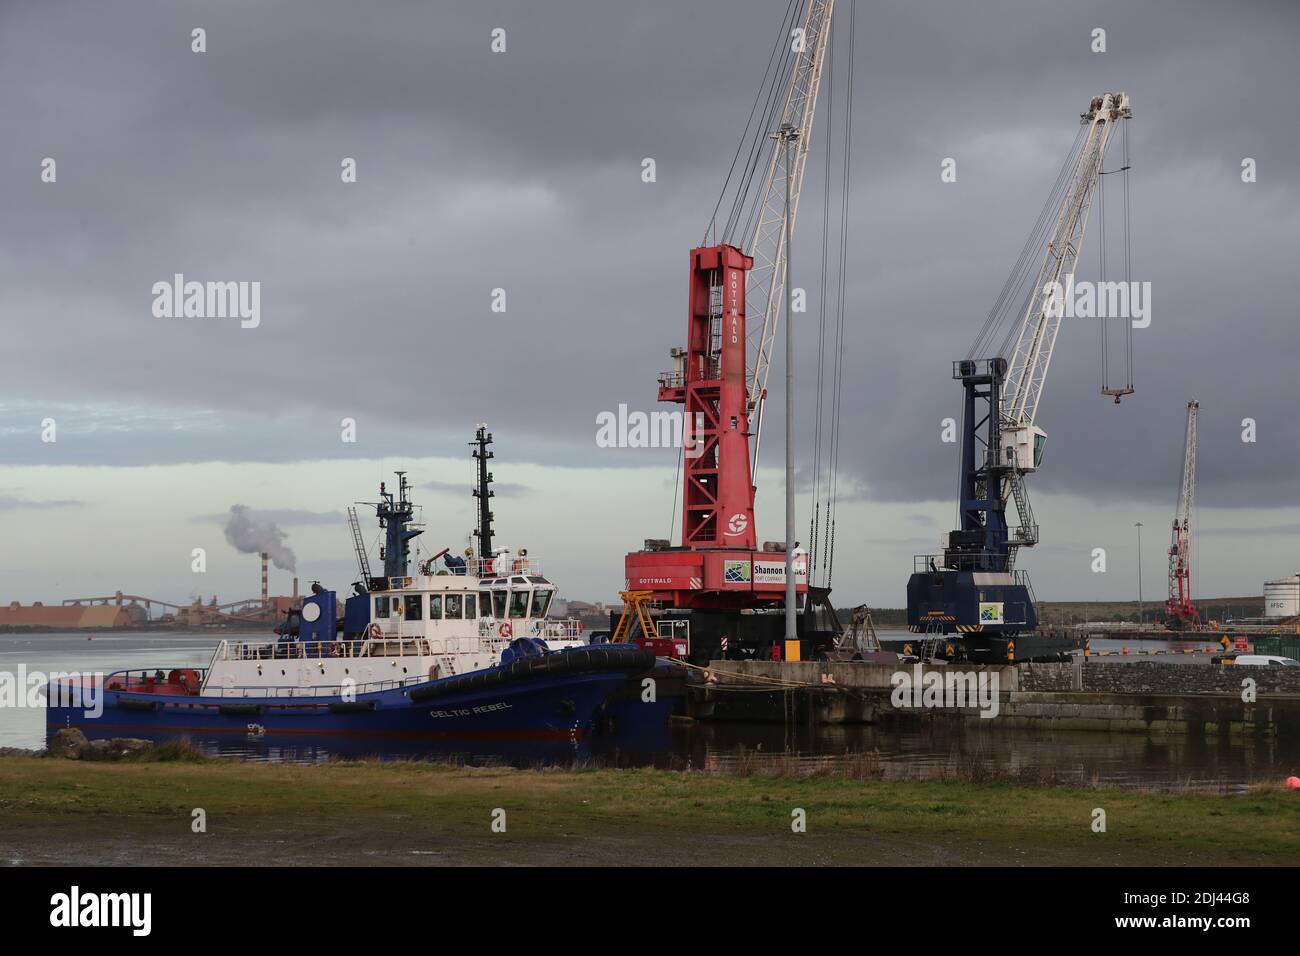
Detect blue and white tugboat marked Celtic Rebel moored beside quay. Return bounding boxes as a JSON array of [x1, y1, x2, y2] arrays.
[[46, 428, 655, 741]]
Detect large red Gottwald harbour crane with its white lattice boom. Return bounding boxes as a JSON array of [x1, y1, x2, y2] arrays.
[[611, 0, 852, 661]]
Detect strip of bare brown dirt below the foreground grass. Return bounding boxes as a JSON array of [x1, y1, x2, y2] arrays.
[[0, 817, 1227, 866]]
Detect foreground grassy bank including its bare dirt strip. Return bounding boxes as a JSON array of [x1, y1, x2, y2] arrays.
[[0, 754, 1300, 865]]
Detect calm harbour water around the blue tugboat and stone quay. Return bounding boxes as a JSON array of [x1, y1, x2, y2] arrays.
[[0, 632, 1300, 792]]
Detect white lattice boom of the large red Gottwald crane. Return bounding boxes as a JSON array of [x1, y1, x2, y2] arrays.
[[745, 0, 835, 473]]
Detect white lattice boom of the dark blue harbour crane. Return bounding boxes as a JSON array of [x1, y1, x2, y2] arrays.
[[1000, 92, 1132, 472]]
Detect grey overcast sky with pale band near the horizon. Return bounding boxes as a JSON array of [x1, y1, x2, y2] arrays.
[[0, 0, 1300, 606]]
